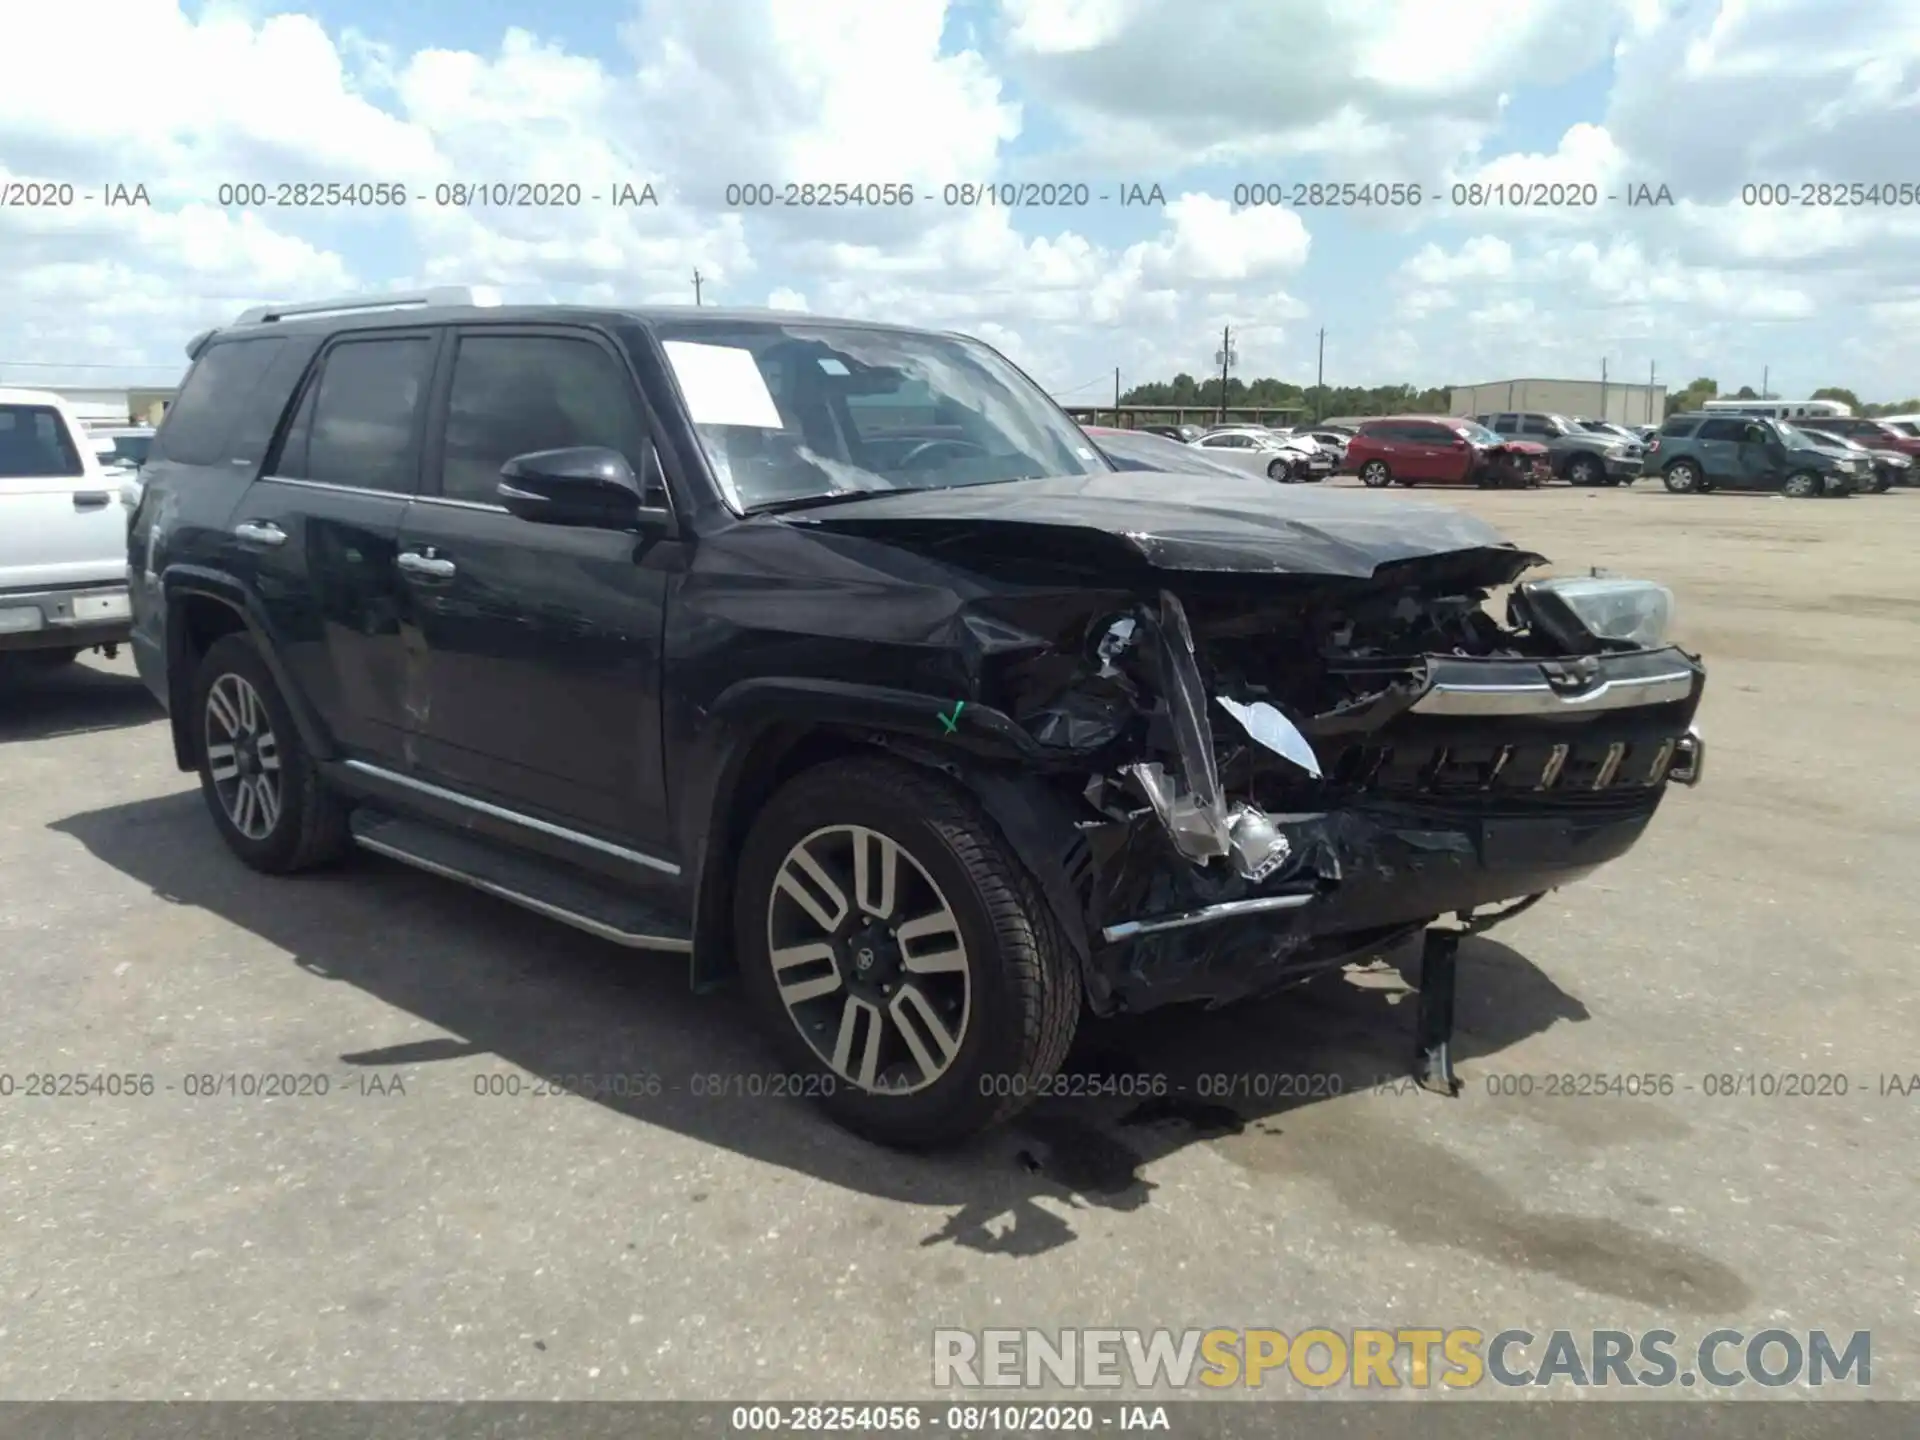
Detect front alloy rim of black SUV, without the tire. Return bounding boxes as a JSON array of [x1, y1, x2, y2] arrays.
[[766, 826, 973, 1094]]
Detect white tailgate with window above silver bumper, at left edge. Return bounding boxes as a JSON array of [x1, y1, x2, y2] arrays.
[[0, 401, 127, 589]]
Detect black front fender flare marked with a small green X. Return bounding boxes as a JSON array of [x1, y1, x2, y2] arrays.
[[676, 678, 1089, 991]]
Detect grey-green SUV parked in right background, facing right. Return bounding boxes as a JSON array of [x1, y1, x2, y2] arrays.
[[1647, 411, 1872, 499]]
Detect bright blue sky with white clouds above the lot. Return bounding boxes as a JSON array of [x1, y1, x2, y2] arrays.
[[0, 0, 1920, 403]]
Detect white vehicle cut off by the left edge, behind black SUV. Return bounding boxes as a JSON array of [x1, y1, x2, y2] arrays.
[[0, 388, 132, 664]]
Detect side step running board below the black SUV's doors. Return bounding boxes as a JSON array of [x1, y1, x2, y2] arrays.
[[349, 806, 693, 954]]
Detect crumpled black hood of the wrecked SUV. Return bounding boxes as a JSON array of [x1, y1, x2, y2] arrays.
[[783, 470, 1542, 584]]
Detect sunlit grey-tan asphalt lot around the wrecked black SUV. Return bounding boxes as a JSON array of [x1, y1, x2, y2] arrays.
[[0, 482, 1920, 1400]]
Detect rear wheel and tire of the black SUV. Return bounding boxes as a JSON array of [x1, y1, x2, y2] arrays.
[[190, 634, 351, 876]]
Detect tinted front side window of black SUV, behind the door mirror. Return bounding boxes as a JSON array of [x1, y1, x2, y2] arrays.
[[440, 334, 647, 505]]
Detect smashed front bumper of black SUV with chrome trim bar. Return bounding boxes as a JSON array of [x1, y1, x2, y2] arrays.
[[1089, 649, 1705, 1014]]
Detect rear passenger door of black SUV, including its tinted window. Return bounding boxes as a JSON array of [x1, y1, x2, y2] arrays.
[[230, 328, 442, 762]]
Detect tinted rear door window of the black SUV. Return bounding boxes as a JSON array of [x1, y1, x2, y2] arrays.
[[275, 336, 434, 493]]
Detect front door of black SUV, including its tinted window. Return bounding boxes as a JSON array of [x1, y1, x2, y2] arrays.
[[397, 326, 680, 858]]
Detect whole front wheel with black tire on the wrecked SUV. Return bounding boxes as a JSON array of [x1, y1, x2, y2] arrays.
[[733, 758, 1081, 1150]]
